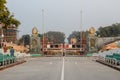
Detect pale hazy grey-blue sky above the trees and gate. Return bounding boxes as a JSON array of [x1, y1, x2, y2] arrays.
[[7, 0, 120, 36]]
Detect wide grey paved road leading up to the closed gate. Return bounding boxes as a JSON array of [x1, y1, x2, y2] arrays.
[[0, 57, 120, 80]]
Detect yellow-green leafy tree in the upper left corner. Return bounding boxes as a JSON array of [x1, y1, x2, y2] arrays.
[[0, 0, 20, 29]]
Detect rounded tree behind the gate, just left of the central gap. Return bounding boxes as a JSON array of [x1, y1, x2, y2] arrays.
[[46, 31, 65, 43]]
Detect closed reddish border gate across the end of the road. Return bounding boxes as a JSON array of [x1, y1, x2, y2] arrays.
[[44, 44, 86, 56]]
